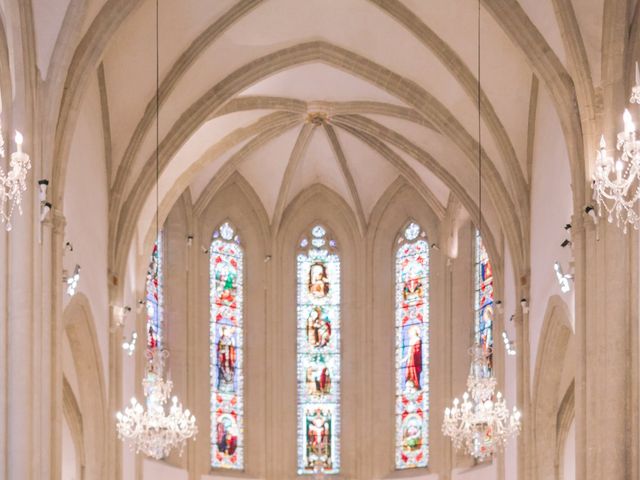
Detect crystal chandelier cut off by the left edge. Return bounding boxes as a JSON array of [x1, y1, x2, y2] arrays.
[[0, 131, 31, 231]]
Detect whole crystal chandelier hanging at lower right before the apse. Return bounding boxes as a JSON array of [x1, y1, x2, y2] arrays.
[[442, 345, 520, 461]]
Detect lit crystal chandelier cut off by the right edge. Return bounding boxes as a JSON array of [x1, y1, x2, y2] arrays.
[[592, 63, 640, 233]]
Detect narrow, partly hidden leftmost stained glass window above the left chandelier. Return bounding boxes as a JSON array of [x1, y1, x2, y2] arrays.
[[145, 232, 163, 349]]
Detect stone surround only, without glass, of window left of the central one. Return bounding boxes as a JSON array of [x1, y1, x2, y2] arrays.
[[188, 173, 274, 478]]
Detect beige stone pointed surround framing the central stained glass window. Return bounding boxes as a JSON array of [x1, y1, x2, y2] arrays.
[[276, 184, 362, 478]]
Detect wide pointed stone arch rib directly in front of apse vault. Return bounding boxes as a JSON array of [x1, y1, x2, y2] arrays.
[[110, 41, 524, 290]]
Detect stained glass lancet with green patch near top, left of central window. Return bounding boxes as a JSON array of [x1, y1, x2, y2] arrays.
[[209, 222, 244, 470]]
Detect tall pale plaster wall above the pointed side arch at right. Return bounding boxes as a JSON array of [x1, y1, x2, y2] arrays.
[[529, 88, 575, 379]]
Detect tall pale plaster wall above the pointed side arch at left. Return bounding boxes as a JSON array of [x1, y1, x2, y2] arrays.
[[63, 75, 109, 385]]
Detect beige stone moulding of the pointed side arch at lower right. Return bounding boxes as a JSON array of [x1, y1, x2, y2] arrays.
[[532, 295, 575, 480]]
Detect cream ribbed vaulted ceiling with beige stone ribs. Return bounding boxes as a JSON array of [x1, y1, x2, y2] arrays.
[[36, 0, 603, 278]]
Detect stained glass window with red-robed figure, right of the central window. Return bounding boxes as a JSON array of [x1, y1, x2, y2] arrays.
[[395, 222, 429, 469]]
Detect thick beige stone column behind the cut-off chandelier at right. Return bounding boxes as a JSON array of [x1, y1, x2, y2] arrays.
[[575, 0, 638, 480]]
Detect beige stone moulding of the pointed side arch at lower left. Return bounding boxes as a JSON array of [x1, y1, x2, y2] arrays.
[[63, 293, 108, 480]]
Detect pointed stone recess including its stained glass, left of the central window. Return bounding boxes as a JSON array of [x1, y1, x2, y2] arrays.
[[195, 172, 270, 477]]
